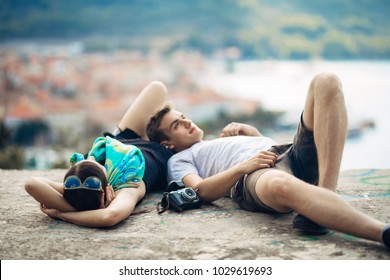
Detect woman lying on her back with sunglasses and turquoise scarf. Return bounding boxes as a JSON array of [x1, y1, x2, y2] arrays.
[[25, 82, 173, 227]]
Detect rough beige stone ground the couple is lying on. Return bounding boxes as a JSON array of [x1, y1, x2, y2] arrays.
[[0, 170, 390, 260]]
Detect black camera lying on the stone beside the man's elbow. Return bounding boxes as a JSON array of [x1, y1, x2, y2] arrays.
[[157, 188, 202, 214]]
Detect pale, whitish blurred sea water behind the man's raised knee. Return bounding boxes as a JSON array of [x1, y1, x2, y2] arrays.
[[203, 61, 390, 170]]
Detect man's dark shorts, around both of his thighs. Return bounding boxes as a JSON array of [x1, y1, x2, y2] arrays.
[[232, 116, 318, 214]]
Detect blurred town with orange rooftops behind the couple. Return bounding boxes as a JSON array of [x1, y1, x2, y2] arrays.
[[0, 42, 266, 168]]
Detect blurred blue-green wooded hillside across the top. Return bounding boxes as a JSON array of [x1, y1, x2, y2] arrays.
[[0, 0, 390, 59]]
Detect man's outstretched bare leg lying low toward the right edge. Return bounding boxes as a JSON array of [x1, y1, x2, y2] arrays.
[[256, 170, 389, 246]]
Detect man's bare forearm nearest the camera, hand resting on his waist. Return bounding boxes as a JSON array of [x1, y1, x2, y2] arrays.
[[182, 151, 277, 203]]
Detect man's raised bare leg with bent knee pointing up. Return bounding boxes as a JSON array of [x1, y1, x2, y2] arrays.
[[303, 74, 348, 191]]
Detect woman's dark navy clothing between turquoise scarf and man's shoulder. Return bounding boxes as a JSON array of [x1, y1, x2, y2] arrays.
[[104, 128, 173, 192]]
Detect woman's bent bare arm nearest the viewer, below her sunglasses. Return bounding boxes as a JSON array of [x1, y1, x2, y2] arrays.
[[42, 183, 145, 227]]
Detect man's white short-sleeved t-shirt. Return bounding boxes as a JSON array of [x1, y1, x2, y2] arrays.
[[168, 136, 277, 186]]
